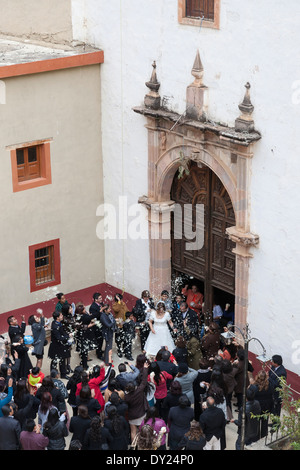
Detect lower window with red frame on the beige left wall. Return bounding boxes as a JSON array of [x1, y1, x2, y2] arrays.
[[29, 239, 60, 292]]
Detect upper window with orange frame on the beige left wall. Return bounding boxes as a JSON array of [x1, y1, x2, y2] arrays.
[[7, 140, 51, 192]]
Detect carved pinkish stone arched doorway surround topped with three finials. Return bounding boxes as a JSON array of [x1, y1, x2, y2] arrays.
[[133, 51, 261, 327]]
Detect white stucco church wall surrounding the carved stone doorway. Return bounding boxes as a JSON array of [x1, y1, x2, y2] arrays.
[[72, 0, 300, 372]]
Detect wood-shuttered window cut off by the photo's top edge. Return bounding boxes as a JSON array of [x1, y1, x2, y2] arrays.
[[178, 0, 220, 29]]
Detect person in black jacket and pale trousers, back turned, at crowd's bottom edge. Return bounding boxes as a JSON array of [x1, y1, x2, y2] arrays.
[[199, 397, 226, 450]]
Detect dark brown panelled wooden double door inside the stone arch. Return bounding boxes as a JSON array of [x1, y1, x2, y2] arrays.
[[171, 162, 235, 312]]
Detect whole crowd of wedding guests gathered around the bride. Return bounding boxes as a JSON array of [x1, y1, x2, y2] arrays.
[[0, 286, 286, 451]]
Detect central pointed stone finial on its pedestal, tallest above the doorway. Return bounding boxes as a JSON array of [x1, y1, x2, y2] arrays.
[[186, 50, 208, 121]]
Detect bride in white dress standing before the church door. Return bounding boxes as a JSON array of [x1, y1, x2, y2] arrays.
[[144, 302, 175, 356]]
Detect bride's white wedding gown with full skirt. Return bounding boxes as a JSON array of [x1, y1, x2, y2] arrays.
[[144, 310, 175, 356]]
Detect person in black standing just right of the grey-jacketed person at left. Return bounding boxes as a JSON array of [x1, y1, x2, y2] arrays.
[[48, 311, 71, 379]]
